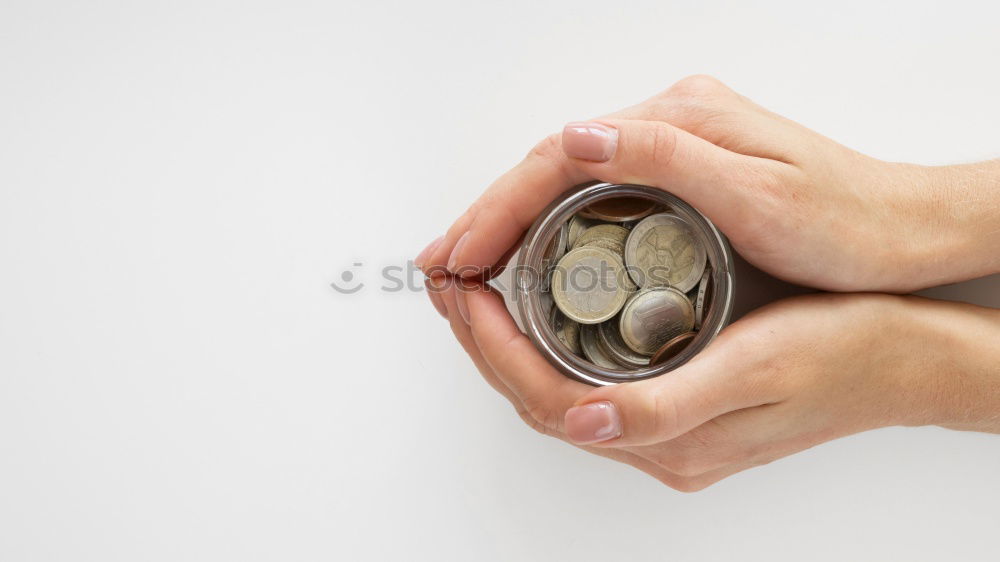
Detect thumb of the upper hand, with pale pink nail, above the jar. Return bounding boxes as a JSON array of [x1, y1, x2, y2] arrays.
[[562, 119, 792, 231]]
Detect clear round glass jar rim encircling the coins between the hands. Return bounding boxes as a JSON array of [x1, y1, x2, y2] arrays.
[[490, 183, 734, 385]]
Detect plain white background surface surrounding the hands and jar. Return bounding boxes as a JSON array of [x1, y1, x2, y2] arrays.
[[0, 0, 1000, 562]]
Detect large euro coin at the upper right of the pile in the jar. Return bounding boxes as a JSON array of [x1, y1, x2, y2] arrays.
[[625, 213, 708, 293]]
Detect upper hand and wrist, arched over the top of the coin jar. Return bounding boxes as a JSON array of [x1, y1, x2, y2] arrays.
[[415, 76, 1000, 292]]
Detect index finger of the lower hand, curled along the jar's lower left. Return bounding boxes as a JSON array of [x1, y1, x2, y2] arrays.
[[458, 280, 592, 432]]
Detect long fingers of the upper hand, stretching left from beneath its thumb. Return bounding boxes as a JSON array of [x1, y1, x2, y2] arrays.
[[419, 135, 590, 276]]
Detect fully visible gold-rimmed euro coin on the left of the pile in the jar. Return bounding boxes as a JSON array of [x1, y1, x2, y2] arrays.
[[552, 246, 630, 324]]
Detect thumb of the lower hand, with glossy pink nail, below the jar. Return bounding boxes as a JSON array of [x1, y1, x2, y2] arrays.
[[565, 348, 780, 447]]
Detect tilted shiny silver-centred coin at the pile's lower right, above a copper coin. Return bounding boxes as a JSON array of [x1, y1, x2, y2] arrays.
[[619, 287, 694, 355]]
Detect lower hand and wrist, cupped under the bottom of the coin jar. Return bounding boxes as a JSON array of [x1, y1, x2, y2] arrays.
[[428, 276, 1000, 491]]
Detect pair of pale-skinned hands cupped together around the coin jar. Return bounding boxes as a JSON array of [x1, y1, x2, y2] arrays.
[[415, 76, 1000, 491]]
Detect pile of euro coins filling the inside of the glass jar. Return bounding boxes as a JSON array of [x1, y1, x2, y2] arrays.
[[541, 197, 712, 370]]
